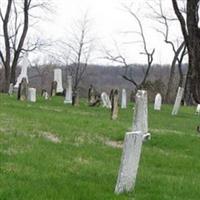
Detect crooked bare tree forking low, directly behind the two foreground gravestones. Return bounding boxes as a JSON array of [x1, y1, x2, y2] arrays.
[[106, 6, 155, 90]]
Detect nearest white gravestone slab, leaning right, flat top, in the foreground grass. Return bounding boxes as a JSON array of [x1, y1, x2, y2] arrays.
[[115, 132, 143, 194]]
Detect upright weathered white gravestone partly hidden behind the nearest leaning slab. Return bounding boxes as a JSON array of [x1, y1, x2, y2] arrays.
[[132, 90, 148, 134]]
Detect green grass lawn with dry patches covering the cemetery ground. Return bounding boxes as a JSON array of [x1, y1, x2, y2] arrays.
[[0, 94, 200, 200]]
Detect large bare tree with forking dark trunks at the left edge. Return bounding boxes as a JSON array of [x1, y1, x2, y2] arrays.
[[0, 0, 50, 91]]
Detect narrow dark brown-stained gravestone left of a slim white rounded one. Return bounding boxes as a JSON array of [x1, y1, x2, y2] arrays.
[[111, 89, 119, 120]]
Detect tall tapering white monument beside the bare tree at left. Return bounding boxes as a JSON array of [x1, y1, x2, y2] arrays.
[[14, 54, 30, 88]]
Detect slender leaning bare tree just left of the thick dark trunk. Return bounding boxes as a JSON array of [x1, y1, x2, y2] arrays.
[[148, 0, 187, 103]]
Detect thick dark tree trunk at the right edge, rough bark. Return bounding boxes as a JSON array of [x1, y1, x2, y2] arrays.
[[172, 0, 200, 104]]
